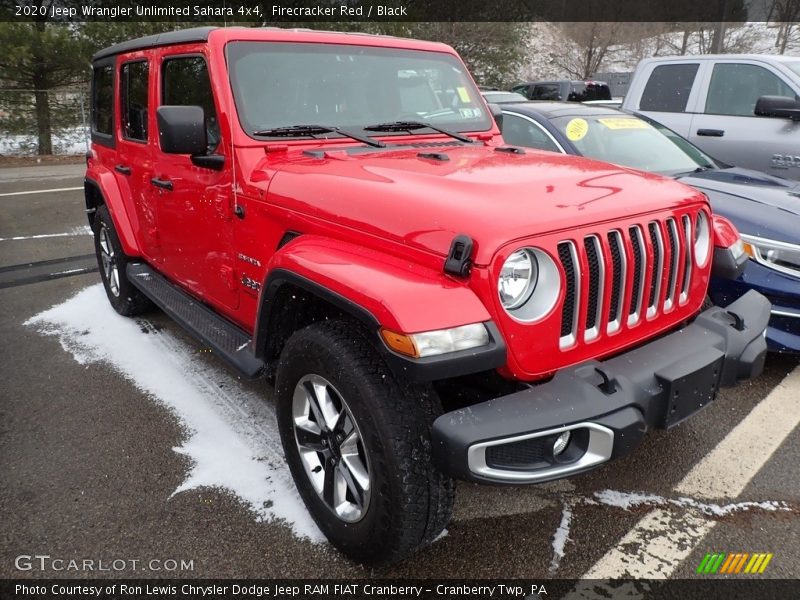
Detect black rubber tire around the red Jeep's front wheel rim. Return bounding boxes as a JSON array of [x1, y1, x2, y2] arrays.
[[275, 321, 454, 564]]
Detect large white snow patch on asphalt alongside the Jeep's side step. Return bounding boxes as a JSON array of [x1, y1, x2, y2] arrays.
[[25, 284, 324, 542]]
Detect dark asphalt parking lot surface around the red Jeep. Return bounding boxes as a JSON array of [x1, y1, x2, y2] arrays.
[[0, 165, 800, 578]]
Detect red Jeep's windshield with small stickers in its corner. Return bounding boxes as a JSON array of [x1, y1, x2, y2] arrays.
[[227, 42, 492, 137]]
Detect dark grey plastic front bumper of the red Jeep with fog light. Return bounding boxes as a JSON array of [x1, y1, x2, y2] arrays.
[[432, 291, 770, 484]]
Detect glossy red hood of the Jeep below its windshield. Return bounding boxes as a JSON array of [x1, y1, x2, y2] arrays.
[[260, 143, 704, 265]]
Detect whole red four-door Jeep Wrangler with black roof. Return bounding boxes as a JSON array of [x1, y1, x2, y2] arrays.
[[85, 28, 769, 562]]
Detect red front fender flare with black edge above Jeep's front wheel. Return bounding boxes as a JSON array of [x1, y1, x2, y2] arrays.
[[253, 236, 506, 381]]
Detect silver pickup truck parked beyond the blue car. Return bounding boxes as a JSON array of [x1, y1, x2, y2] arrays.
[[622, 54, 800, 179]]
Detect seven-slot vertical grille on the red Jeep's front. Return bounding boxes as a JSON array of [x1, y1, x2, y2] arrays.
[[558, 215, 693, 348]]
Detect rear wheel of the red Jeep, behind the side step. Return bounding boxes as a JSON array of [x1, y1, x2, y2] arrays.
[[93, 205, 153, 317]]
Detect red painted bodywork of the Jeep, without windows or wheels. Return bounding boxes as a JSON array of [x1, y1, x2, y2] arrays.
[[87, 28, 710, 380]]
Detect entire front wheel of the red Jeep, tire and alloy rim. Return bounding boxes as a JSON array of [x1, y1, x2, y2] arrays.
[[275, 321, 454, 563]]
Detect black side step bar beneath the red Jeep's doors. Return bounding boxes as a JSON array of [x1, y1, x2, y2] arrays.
[[126, 263, 264, 379]]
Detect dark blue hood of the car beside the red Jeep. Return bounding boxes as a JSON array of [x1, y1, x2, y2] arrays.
[[680, 167, 800, 244]]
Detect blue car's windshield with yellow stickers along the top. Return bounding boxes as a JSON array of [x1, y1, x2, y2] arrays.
[[553, 115, 715, 175]]
